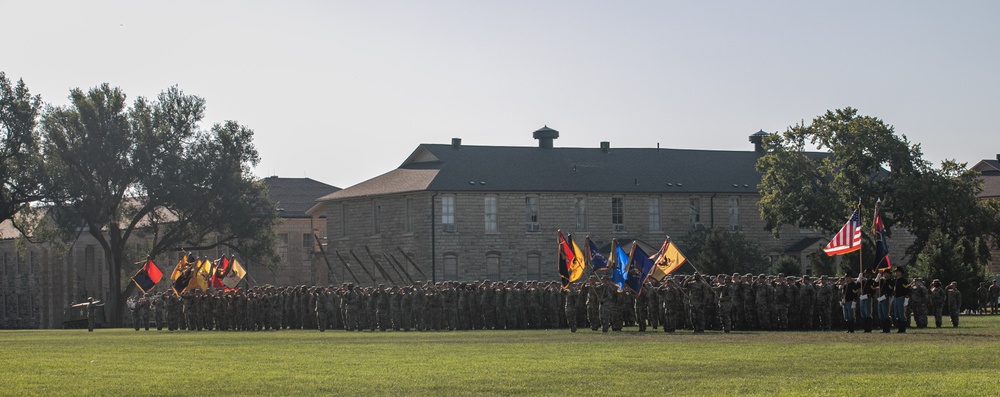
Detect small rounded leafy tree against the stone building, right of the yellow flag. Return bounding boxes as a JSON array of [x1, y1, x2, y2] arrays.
[[678, 227, 767, 274]]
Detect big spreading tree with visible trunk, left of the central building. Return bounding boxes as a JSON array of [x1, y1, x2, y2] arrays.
[[41, 84, 277, 325]]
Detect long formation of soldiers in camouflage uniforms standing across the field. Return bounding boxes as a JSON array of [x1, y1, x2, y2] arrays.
[[128, 273, 976, 332]]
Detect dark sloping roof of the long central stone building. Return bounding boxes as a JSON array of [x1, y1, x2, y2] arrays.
[[319, 131, 825, 201]]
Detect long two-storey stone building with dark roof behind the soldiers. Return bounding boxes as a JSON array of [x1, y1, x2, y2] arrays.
[[310, 127, 832, 284]]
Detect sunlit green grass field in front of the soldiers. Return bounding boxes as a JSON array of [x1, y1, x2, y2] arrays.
[[0, 316, 1000, 396]]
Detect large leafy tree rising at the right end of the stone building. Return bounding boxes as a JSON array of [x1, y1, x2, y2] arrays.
[[757, 108, 1000, 265]]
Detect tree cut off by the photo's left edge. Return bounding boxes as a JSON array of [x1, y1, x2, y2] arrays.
[[0, 72, 42, 224]]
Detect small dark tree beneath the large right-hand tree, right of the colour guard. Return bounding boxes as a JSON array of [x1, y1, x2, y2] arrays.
[[910, 231, 987, 308]]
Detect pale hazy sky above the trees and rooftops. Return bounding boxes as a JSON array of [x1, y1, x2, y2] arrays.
[[0, 0, 1000, 188]]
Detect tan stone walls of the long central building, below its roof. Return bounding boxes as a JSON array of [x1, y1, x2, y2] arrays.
[[326, 192, 836, 285]]
